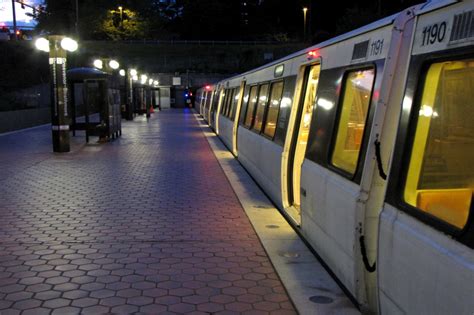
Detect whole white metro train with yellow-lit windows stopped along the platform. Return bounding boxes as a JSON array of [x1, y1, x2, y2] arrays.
[[194, 0, 474, 314]]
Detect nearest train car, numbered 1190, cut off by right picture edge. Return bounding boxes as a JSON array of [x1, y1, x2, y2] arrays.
[[377, 1, 474, 314]]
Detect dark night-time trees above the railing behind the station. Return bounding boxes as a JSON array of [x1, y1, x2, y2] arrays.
[[38, 0, 422, 43]]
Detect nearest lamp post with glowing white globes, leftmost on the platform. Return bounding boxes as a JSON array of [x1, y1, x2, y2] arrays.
[[35, 35, 78, 152]]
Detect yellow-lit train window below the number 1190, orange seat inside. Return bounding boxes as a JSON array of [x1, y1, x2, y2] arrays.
[[404, 59, 474, 229]]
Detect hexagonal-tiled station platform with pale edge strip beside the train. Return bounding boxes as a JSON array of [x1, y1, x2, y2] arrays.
[[0, 109, 359, 315]]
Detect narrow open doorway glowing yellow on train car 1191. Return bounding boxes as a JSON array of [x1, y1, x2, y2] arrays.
[[285, 64, 321, 224]]
